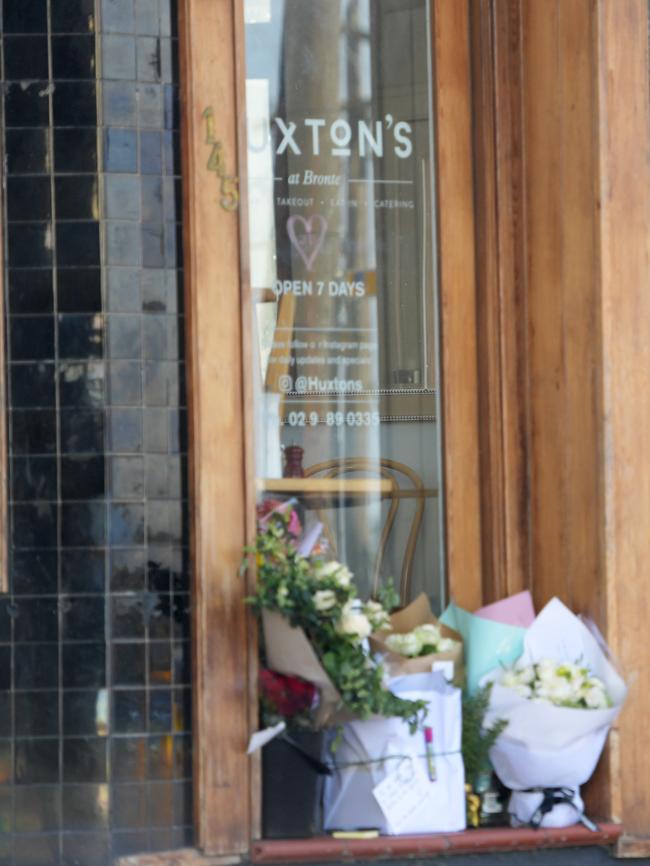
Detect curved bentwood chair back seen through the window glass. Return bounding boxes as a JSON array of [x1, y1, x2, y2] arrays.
[[305, 457, 434, 604]]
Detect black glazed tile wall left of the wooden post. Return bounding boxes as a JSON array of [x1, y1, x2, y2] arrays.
[[0, 0, 192, 866]]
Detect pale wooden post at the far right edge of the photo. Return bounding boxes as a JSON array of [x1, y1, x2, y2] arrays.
[[598, 0, 650, 857]]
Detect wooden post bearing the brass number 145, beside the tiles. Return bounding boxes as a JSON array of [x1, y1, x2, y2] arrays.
[[180, 0, 254, 855]]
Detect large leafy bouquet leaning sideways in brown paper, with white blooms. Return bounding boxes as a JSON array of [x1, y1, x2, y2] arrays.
[[248, 509, 424, 728]]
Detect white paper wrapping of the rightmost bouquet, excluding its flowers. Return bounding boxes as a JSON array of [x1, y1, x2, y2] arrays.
[[485, 598, 627, 826]]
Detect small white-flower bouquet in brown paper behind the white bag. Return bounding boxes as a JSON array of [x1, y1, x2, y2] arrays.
[[370, 593, 464, 686]]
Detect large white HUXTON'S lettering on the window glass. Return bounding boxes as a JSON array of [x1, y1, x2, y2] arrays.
[[249, 114, 413, 159]]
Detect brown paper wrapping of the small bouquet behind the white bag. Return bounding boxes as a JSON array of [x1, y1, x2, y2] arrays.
[[370, 593, 465, 688]]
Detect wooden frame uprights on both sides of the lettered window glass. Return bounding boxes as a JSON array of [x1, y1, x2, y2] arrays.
[[180, 0, 482, 856]]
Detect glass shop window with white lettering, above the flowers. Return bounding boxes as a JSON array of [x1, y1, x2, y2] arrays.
[[245, 0, 444, 607]]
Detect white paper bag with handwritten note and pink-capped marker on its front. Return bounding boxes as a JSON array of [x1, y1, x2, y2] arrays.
[[324, 673, 465, 835]]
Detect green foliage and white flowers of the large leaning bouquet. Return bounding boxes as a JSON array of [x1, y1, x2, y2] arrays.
[[247, 515, 426, 730]]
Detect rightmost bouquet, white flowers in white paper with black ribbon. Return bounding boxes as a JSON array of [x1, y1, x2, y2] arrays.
[[485, 598, 626, 827]]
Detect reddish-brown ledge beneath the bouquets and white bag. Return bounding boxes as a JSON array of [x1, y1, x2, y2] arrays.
[[251, 822, 623, 863]]
